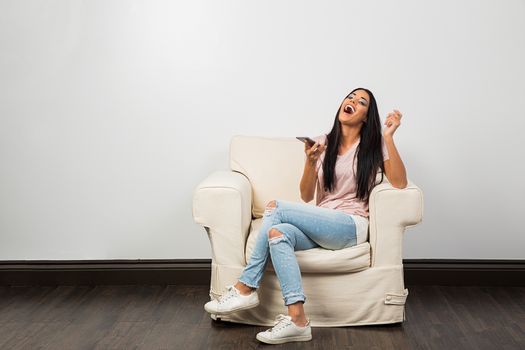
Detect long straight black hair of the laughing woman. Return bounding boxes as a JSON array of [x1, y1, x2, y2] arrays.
[[323, 88, 385, 203]]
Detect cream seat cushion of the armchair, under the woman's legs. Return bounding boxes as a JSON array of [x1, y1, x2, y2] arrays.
[[246, 218, 370, 273]]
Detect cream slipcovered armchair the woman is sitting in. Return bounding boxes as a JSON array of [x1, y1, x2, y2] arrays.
[[193, 136, 423, 327]]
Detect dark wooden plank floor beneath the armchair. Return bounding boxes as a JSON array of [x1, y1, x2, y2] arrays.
[[0, 286, 525, 350]]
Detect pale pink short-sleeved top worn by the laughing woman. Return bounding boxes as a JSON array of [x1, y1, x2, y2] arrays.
[[313, 135, 389, 218]]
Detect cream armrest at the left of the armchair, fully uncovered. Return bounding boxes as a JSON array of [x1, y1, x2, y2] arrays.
[[193, 171, 252, 266]]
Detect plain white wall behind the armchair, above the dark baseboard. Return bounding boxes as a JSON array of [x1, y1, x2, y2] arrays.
[[0, 0, 525, 260]]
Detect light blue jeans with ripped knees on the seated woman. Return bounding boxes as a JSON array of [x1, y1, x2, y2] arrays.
[[239, 200, 357, 305]]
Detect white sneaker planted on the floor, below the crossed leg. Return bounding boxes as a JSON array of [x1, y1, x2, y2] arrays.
[[256, 315, 312, 344]]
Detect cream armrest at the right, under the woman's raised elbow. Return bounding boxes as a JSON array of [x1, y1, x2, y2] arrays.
[[369, 180, 423, 266]]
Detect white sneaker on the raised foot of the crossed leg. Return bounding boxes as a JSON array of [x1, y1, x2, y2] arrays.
[[204, 285, 259, 315]]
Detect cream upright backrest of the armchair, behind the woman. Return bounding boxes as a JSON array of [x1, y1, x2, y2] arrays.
[[230, 135, 313, 218]]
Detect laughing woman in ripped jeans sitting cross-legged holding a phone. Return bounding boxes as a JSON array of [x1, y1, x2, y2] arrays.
[[204, 88, 408, 344]]
